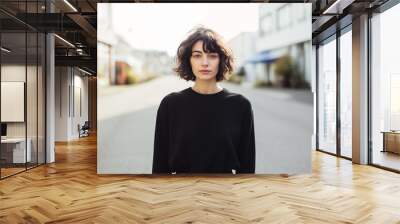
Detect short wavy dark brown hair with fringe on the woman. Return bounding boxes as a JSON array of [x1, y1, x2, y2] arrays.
[[174, 27, 233, 81]]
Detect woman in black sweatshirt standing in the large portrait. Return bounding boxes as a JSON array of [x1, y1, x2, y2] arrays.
[[153, 27, 255, 174]]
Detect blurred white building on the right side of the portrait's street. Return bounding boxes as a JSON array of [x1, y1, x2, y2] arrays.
[[256, 3, 312, 86]]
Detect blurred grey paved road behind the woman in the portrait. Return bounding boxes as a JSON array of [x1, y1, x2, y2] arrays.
[[98, 76, 313, 174]]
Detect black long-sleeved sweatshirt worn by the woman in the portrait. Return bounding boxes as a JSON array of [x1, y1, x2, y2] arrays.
[[153, 87, 255, 173]]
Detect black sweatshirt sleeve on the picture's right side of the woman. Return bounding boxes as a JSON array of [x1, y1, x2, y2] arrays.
[[237, 101, 256, 173]]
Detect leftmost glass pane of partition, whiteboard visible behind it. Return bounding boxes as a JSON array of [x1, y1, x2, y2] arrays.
[[0, 32, 30, 178]]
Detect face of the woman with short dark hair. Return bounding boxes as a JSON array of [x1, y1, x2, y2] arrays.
[[190, 40, 219, 80]]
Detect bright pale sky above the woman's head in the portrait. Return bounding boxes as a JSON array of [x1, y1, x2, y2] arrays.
[[109, 3, 260, 56]]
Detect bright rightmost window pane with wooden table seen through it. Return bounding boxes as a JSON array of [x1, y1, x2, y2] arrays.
[[371, 4, 400, 170]]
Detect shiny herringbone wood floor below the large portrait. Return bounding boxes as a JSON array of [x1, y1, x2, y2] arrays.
[[0, 135, 400, 224]]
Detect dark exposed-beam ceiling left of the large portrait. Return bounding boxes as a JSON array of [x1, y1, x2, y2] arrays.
[[0, 0, 99, 74]]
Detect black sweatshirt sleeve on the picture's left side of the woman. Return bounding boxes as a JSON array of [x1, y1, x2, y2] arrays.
[[153, 98, 170, 174]]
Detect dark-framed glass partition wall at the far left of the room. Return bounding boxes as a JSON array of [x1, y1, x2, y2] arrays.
[[0, 0, 45, 178]]
